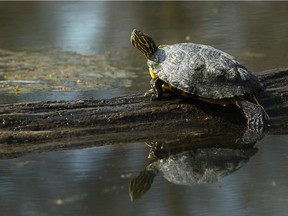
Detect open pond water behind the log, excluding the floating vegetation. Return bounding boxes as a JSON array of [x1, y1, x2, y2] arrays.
[[0, 2, 288, 103]]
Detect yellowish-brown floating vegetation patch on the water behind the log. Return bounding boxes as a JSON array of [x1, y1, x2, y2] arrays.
[[0, 49, 140, 94]]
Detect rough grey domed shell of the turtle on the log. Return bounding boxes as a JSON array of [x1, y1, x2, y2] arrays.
[[147, 43, 262, 99]]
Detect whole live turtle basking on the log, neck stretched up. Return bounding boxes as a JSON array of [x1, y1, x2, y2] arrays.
[[131, 30, 269, 127]]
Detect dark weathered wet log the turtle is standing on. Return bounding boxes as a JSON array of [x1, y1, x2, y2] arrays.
[[0, 69, 288, 157]]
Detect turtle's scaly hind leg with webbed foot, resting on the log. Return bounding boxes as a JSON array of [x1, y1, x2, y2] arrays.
[[235, 99, 269, 128]]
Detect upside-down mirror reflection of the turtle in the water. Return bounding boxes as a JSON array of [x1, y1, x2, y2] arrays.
[[129, 147, 257, 200]]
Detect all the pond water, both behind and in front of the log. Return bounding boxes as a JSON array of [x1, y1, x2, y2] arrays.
[[0, 2, 288, 216]]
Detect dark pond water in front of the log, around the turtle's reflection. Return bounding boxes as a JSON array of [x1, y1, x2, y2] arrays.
[[0, 135, 288, 216]]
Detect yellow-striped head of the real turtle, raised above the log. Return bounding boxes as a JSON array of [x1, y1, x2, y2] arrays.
[[130, 29, 158, 59]]
